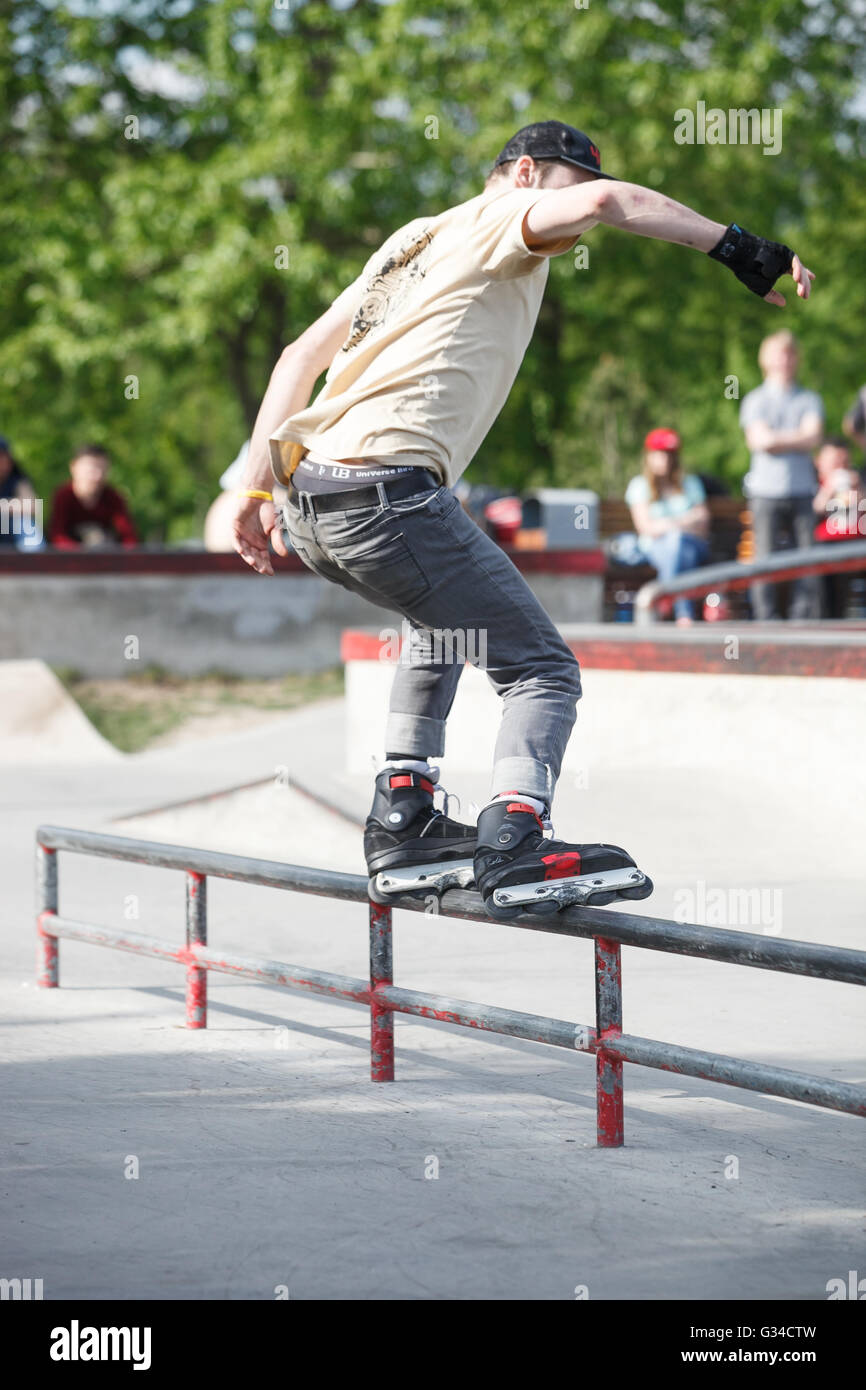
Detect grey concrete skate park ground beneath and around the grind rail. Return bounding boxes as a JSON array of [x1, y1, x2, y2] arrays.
[[0, 701, 866, 1300]]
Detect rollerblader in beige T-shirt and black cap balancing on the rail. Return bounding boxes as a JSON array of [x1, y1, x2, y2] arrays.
[[234, 121, 813, 917]]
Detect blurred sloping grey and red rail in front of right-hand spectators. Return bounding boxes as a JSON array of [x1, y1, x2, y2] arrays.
[[634, 541, 866, 624]]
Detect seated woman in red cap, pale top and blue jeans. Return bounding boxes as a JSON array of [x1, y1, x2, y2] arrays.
[[626, 430, 710, 626]]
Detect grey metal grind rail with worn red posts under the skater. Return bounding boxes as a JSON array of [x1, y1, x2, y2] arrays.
[[36, 826, 866, 1148]]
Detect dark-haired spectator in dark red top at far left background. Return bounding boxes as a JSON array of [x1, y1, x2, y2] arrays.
[[49, 443, 138, 550]]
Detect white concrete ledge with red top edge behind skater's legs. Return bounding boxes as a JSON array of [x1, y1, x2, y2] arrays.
[[342, 620, 866, 800]]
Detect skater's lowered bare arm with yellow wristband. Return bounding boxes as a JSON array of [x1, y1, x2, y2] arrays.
[[231, 285, 357, 574]]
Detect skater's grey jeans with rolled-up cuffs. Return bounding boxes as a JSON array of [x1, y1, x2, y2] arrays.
[[284, 484, 581, 803]]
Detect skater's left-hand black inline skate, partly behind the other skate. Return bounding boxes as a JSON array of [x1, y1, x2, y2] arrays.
[[364, 765, 475, 902]]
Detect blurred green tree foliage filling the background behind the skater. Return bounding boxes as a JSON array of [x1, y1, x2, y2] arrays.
[[0, 0, 866, 541]]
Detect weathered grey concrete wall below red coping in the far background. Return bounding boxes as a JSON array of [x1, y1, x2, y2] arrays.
[[0, 574, 602, 677]]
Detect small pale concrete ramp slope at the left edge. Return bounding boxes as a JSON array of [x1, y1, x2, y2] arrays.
[[0, 660, 122, 767]]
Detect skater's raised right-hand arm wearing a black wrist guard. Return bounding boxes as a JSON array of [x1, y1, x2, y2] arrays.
[[524, 179, 815, 306]]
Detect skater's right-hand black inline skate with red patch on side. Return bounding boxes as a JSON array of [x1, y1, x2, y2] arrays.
[[474, 794, 652, 922]]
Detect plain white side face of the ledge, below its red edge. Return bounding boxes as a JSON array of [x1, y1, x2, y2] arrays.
[[345, 660, 866, 834]]
